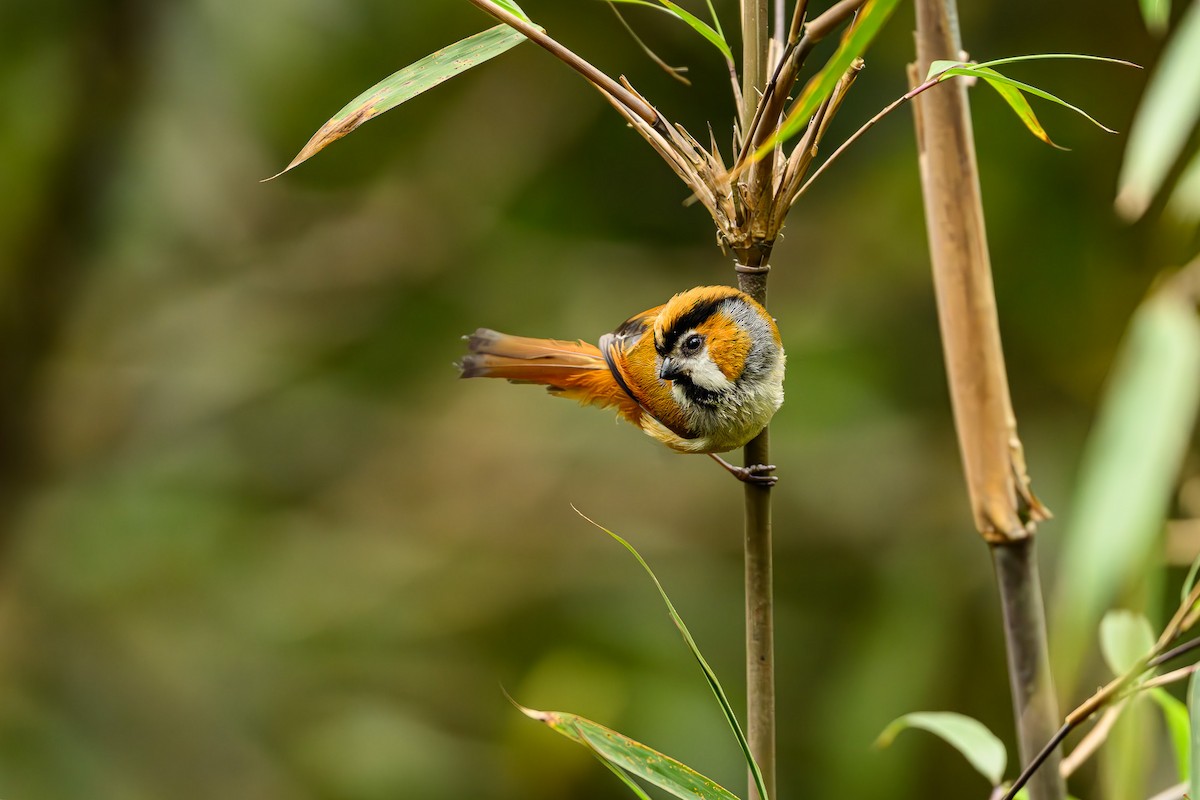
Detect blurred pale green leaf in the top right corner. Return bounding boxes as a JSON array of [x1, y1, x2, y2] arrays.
[[1116, 2, 1200, 219]]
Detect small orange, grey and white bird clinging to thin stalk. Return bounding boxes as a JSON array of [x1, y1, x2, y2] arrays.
[[457, 285, 787, 486]]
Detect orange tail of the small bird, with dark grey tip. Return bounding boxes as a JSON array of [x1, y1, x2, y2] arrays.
[[458, 327, 608, 391]]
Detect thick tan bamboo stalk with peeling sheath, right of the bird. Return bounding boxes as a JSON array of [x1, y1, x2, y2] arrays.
[[910, 0, 1066, 800]]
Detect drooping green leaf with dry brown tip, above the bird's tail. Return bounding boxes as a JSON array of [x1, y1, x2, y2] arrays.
[[268, 23, 526, 180]]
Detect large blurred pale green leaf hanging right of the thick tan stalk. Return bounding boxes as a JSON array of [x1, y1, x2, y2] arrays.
[[1051, 290, 1200, 691]]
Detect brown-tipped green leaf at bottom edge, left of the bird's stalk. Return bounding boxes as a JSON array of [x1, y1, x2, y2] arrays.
[[517, 705, 738, 800]]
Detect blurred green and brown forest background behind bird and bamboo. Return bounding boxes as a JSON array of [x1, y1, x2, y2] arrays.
[[0, 0, 1196, 800]]
